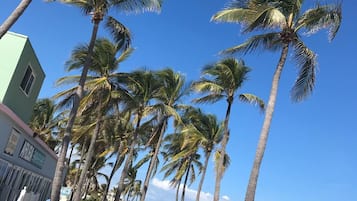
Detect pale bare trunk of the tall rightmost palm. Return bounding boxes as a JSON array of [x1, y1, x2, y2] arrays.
[[245, 44, 289, 201]]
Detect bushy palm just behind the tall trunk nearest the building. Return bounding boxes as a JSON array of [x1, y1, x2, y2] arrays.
[[54, 39, 132, 201]]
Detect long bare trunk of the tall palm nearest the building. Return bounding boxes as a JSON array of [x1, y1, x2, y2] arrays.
[[51, 21, 100, 201]]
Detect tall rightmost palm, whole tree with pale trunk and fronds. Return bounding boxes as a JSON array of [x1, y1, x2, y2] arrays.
[[212, 0, 342, 201]]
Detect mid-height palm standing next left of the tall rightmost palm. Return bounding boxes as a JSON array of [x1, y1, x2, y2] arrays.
[[192, 58, 264, 201]]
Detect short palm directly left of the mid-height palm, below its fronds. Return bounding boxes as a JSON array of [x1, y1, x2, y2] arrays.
[[182, 109, 224, 201]]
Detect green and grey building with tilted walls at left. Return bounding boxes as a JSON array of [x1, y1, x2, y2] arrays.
[[0, 32, 57, 201]]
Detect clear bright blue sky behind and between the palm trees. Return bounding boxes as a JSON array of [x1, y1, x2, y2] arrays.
[[0, 0, 357, 201]]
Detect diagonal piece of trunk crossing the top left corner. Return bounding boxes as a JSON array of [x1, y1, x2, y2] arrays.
[[0, 0, 32, 39]]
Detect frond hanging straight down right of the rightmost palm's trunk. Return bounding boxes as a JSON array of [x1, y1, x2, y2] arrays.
[[291, 37, 317, 101]]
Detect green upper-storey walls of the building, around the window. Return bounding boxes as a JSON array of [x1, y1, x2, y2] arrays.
[[0, 33, 45, 123]]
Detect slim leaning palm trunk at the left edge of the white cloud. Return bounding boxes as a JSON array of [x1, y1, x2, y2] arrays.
[[140, 117, 167, 201]]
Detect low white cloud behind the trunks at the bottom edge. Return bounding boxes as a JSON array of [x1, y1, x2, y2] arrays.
[[147, 178, 230, 201]]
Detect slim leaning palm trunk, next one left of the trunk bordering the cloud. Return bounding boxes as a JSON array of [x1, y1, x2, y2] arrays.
[[114, 116, 141, 201]]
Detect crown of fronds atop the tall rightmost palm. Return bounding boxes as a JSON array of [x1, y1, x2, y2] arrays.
[[212, 1, 342, 101]]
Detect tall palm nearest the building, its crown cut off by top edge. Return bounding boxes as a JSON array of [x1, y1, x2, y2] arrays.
[[51, 0, 161, 201]]
